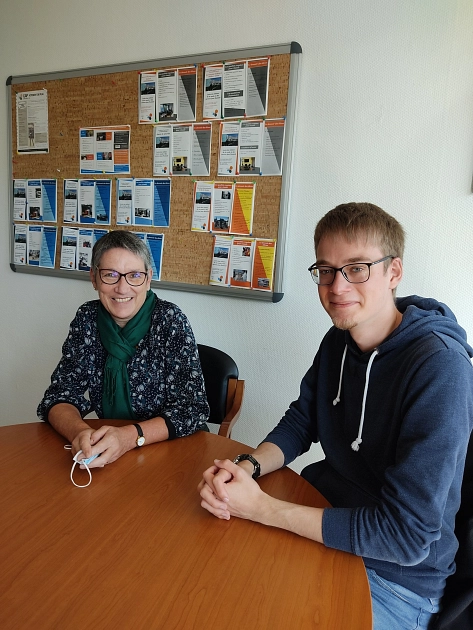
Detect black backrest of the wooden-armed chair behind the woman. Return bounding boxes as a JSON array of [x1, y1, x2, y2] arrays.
[[197, 343, 238, 424]]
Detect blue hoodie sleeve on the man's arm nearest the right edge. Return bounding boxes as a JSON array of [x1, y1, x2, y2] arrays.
[[322, 349, 473, 566]]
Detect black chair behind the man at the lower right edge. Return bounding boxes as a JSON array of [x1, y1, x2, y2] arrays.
[[432, 436, 473, 630]]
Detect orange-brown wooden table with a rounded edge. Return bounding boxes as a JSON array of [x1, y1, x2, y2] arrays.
[[0, 423, 371, 630]]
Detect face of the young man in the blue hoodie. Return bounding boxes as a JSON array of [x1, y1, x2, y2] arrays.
[[317, 235, 402, 345]]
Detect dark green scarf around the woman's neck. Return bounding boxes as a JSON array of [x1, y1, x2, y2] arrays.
[[97, 290, 156, 420]]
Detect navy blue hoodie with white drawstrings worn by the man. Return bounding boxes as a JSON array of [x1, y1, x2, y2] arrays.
[[265, 296, 473, 597]]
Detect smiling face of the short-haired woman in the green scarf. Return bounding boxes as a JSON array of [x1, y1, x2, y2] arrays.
[[90, 247, 153, 328]]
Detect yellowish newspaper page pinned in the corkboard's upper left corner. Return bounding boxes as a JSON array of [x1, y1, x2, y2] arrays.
[[16, 90, 49, 153]]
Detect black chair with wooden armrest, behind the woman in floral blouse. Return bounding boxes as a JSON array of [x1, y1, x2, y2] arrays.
[[197, 343, 245, 438]]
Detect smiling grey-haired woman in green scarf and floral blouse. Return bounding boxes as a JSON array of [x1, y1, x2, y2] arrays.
[[38, 230, 208, 468]]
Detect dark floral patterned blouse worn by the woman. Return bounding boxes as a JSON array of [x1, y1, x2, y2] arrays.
[[37, 298, 209, 439]]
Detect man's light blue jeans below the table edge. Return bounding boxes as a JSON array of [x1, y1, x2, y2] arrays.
[[366, 568, 440, 630]]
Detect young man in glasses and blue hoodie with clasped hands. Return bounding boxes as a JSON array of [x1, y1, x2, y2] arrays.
[[199, 203, 473, 630]]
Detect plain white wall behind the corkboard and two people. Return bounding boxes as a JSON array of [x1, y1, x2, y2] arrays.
[[0, 0, 473, 469]]
